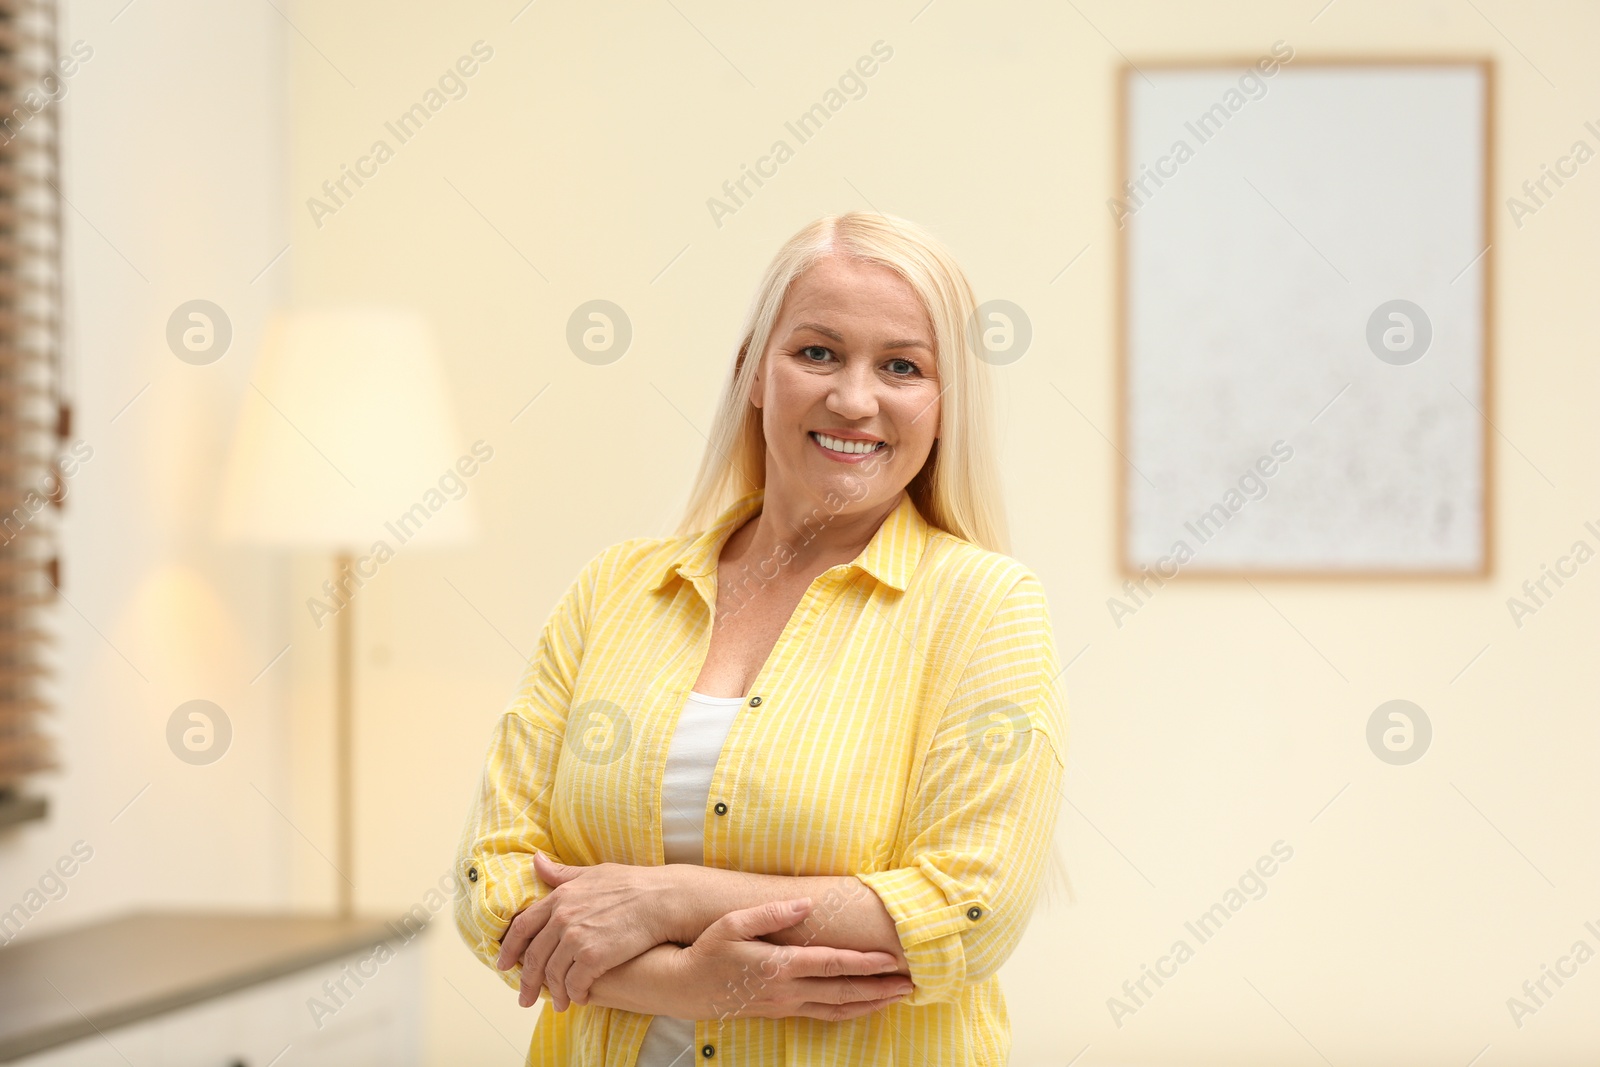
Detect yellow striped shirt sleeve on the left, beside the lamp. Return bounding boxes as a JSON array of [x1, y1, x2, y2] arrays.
[[454, 553, 603, 987]]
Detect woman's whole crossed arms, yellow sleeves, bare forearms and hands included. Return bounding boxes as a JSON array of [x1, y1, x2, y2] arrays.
[[456, 573, 1066, 1021]]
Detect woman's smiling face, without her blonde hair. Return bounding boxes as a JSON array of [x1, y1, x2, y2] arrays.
[[750, 256, 941, 510]]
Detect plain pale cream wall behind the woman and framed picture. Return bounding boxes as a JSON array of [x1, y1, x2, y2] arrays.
[[286, 0, 1600, 1065]]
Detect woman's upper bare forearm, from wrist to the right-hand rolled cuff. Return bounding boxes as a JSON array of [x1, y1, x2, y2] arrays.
[[667, 864, 907, 974]]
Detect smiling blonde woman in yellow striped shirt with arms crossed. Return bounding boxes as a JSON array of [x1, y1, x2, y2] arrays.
[[456, 213, 1066, 1067]]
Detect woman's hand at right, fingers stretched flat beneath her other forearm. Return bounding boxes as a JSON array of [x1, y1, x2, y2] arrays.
[[662, 899, 912, 1022]]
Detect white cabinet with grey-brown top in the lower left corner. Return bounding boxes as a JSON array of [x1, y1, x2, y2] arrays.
[[0, 913, 422, 1067]]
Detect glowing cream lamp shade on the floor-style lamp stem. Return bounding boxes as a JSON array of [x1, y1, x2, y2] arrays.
[[216, 300, 477, 552]]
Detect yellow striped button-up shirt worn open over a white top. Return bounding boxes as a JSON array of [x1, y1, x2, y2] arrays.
[[456, 490, 1067, 1067]]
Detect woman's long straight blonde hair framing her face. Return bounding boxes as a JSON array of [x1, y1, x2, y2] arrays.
[[677, 211, 1010, 553]]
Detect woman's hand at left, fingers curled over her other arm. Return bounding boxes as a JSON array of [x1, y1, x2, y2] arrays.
[[496, 853, 674, 1011]]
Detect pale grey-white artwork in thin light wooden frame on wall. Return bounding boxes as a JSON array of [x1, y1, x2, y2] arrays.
[[1107, 58, 1493, 577]]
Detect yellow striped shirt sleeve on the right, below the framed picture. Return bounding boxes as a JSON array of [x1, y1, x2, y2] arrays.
[[858, 573, 1067, 1005]]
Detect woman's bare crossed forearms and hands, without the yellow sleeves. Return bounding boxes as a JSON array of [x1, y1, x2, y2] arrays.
[[496, 854, 912, 1022]]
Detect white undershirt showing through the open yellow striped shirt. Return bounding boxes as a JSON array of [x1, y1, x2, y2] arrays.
[[635, 689, 744, 1067]]
